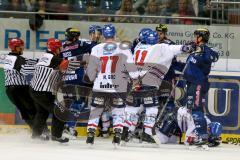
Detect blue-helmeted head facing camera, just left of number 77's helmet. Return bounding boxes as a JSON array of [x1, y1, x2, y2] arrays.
[[88, 25, 102, 42]]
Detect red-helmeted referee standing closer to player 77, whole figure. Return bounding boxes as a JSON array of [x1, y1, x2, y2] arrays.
[[30, 38, 69, 143]]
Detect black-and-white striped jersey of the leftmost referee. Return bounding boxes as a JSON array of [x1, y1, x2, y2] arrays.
[[3, 53, 29, 86]]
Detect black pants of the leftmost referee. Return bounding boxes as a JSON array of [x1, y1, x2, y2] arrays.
[[6, 85, 36, 128]]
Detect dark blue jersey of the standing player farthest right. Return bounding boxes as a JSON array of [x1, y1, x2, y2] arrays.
[[183, 45, 218, 86]]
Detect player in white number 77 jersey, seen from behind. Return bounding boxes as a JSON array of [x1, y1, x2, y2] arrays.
[[86, 24, 138, 144]]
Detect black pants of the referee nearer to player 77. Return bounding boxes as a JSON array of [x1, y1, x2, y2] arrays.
[[30, 89, 64, 138]]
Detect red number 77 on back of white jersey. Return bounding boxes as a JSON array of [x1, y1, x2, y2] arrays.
[[100, 56, 119, 73]]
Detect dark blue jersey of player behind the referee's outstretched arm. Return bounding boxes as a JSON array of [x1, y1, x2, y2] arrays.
[[60, 40, 97, 85]]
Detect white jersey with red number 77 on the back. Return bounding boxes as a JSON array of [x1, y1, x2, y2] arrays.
[[86, 43, 138, 92]]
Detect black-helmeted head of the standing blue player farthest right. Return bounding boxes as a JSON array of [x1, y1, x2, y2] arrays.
[[194, 28, 210, 44]]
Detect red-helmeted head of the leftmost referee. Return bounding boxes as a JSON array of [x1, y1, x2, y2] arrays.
[[8, 38, 24, 55]]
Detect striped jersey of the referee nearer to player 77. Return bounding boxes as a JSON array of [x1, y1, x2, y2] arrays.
[[30, 53, 62, 92]]
